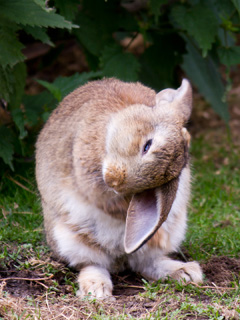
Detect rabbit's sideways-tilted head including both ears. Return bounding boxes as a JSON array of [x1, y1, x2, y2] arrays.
[[102, 79, 192, 253]]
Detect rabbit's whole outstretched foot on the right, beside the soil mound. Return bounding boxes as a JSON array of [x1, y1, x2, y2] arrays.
[[129, 251, 202, 283]]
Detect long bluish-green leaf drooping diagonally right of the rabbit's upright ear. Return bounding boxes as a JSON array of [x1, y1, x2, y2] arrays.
[[182, 42, 229, 122]]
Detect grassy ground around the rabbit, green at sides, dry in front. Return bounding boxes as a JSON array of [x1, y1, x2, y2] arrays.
[[0, 131, 240, 320]]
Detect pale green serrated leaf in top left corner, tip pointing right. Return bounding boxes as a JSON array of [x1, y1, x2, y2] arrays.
[[0, 0, 78, 29]]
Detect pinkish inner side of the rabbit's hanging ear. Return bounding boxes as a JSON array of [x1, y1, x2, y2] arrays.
[[124, 189, 161, 253]]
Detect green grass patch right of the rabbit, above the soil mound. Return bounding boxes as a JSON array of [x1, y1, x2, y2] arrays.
[[187, 139, 240, 260]]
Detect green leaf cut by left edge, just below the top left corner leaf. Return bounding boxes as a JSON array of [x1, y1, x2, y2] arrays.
[[0, 26, 25, 68]]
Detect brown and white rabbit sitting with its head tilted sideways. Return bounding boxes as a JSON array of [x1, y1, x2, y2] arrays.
[[36, 78, 202, 299]]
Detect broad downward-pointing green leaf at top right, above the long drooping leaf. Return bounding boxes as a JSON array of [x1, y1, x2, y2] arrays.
[[171, 3, 219, 57]]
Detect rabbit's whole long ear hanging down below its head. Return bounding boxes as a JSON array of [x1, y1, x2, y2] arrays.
[[124, 178, 178, 253]]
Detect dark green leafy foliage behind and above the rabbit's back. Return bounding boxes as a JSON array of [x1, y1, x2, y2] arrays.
[[0, 0, 240, 168]]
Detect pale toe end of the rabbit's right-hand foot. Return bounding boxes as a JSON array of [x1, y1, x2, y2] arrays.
[[170, 262, 202, 283]]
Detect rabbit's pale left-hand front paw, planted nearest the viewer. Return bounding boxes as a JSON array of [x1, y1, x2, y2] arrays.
[[77, 265, 114, 299]]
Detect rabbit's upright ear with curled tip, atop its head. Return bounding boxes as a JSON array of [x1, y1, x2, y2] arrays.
[[156, 79, 192, 123]]
